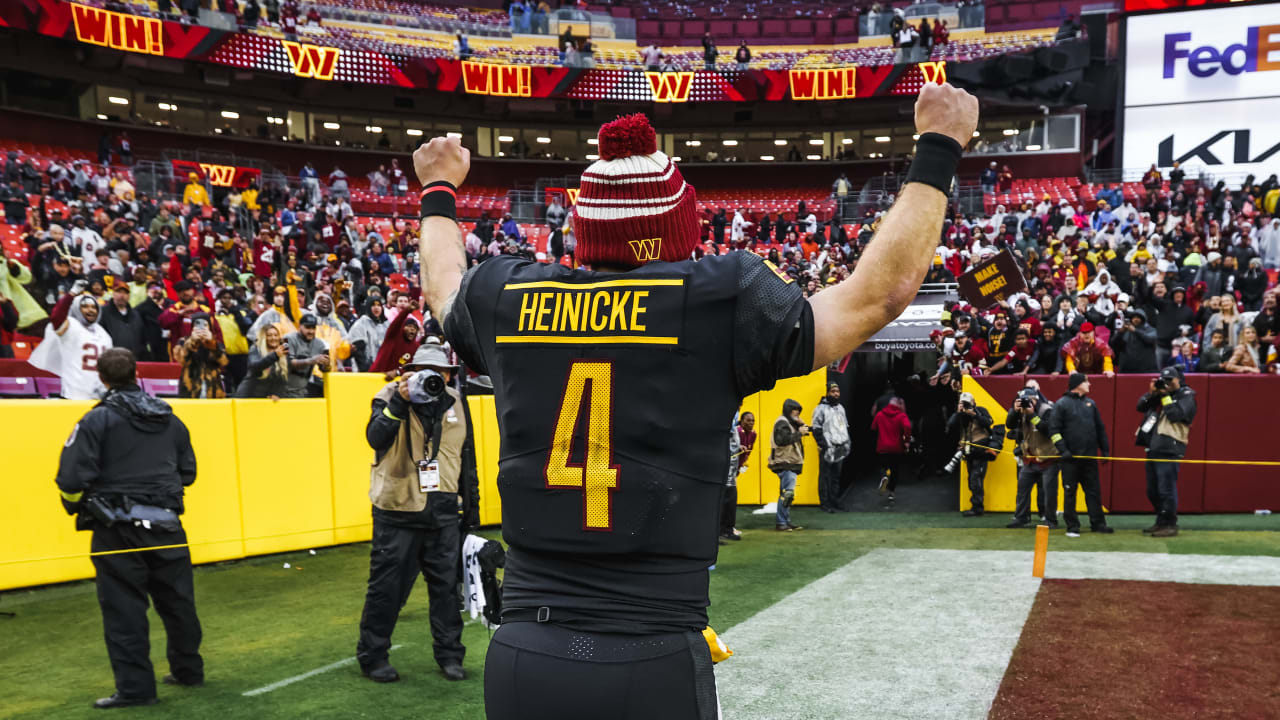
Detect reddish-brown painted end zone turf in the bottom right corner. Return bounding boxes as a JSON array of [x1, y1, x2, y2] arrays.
[[991, 579, 1280, 720]]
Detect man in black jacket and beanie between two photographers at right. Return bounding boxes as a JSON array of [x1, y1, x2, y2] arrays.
[[1048, 373, 1115, 538]]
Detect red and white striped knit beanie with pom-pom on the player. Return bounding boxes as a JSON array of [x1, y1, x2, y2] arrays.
[[573, 113, 699, 268]]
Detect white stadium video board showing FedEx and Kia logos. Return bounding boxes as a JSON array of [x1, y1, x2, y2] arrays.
[[1124, 4, 1280, 177]]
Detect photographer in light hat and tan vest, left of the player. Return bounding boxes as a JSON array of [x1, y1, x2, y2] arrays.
[[356, 341, 480, 683]]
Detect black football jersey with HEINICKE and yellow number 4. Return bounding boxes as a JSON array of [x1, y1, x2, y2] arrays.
[[444, 252, 813, 633]]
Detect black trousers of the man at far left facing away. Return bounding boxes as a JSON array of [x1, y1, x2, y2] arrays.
[[91, 524, 205, 698]]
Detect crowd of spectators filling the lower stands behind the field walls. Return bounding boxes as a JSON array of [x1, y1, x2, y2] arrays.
[[0, 141, 1280, 397]]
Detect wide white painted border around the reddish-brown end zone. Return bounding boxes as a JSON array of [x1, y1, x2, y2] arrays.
[[716, 550, 1280, 720]]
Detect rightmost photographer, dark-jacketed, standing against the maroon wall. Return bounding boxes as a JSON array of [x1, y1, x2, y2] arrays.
[[1138, 365, 1196, 538]]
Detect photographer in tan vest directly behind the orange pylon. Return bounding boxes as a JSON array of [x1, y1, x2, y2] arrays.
[[1005, 387, 1057, 529]]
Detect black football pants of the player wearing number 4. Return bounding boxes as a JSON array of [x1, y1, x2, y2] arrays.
[[484, 623, 718, 720]]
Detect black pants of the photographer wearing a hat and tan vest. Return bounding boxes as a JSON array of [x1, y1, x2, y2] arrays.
[[356, 514, 466, 667]]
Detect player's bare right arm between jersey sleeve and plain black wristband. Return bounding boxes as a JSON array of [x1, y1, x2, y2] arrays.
[[810, 183, 947, 369]]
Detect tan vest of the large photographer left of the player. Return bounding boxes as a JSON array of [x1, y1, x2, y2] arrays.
[[369, 383, 467, 512]]
